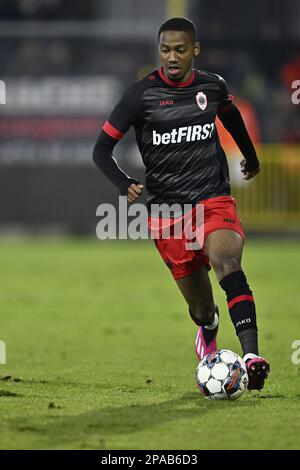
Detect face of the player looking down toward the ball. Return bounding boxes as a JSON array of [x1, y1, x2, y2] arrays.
[[159, 31, 200, 82]]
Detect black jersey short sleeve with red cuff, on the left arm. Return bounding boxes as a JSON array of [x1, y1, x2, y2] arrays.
[[103, 84, 141, 140]]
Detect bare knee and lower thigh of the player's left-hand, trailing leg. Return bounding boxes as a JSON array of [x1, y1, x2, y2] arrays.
[[176, 264, 213, 307]]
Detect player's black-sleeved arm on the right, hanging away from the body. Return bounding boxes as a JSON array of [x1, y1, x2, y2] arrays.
[[218, 102, 260, 180]]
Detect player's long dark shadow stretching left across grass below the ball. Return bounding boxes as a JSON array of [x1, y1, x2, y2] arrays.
[[10, 392, 262, 449]]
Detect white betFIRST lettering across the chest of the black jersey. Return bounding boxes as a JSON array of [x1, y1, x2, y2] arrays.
[[152, 122, 215, 145]]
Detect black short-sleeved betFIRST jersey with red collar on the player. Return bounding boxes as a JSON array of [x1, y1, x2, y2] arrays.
[[98, 68, 258, 204]]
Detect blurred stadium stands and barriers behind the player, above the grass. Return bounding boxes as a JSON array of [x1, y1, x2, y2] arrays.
[[0, 0, 300, 236]]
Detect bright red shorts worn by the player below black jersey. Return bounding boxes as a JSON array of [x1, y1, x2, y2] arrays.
[[148, 196, 245, 279]]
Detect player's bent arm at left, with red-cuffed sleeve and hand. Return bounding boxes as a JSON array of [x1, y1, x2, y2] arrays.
[[93, 86, 144, 202]]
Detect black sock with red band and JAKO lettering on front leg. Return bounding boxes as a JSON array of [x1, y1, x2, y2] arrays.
[[220, 271, 258, 355]]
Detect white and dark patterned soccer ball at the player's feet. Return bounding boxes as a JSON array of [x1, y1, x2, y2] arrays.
[[196, 349, 249, 400]]
